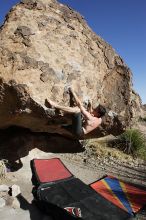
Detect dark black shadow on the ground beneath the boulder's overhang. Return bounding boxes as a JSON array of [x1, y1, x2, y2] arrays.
[[0, 126, 84, 171]]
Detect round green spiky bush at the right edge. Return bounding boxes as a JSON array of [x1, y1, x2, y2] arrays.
[[118, 129, 146, 159]]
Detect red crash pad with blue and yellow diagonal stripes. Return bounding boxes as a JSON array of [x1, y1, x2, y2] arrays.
[[90, 176, 146, 215]]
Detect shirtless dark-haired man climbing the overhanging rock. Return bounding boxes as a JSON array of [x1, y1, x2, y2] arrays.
[[46, 88, 106, 138]]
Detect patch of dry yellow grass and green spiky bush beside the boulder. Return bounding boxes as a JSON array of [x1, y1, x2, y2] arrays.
[[83, 129, 146, 161]]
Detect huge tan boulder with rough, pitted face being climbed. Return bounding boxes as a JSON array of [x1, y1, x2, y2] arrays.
[[0, 0, 141, 137]]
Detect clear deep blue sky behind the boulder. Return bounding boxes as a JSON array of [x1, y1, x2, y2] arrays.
[[0, 0, 146, 104]]
